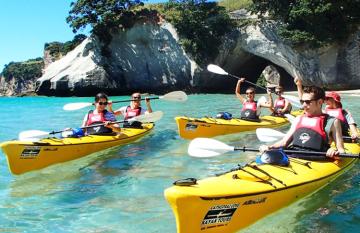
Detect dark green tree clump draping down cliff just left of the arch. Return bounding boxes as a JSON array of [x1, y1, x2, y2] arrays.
[[150, 0, 234, 64]]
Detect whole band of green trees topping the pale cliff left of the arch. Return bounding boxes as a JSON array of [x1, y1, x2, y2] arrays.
[[66, 0, 233, 63]]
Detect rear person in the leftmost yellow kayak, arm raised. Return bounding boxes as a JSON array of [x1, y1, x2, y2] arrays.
[[109, 92, 152, 128]]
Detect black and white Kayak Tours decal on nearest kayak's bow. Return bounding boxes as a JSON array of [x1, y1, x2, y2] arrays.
[[201, 203, 240, 230]]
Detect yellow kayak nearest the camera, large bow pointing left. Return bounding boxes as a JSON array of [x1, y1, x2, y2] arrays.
[[164, 144, 360, 233]]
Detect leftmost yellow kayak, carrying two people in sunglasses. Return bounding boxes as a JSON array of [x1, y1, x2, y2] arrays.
[[1, 123, 154, 175]]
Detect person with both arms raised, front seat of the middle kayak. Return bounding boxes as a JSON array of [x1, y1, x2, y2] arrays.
[[235, 78, 273, 121]]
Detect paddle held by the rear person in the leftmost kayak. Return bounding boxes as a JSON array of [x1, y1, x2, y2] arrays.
[[63, 91, 187, 111]]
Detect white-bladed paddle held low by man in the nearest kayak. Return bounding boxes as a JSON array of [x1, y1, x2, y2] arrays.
[[188, 138, 360, 158]]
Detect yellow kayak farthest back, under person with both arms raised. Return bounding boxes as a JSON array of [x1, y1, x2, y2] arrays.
[[175, 111, 302, 139]]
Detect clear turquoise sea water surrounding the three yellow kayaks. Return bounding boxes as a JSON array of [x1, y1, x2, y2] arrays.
[[0, 95, 360, 233]]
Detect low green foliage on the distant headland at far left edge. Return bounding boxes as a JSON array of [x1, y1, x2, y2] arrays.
[[2, 57, 44, 80]]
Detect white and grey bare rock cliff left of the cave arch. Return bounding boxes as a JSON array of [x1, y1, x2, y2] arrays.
[[37, 23, 194, 96]]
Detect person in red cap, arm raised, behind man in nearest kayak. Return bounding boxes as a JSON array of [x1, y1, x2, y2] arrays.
[[294, 77, 359, 139]]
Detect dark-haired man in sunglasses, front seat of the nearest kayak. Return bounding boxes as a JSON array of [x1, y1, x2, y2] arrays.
[[260, 86, 344, 158]]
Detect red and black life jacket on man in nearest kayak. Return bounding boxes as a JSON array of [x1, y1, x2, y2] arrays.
[[292, 114, 329, 151]]
